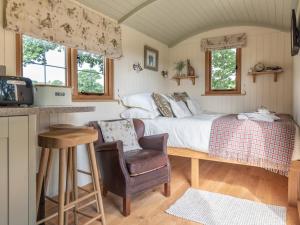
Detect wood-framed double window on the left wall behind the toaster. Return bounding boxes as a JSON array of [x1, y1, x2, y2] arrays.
[[16, 35, 113, 101]]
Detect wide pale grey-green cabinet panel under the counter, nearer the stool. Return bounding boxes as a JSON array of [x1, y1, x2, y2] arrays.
[[8, 116, 29, 225]]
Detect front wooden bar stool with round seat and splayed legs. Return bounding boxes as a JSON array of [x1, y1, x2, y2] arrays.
[[36, 128, 106, 225]]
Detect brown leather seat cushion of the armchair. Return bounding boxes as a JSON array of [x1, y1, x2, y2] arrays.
[[124, 149, 168, 176]]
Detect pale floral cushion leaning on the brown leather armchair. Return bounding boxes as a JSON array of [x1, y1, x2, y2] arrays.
[[99, 119, 141, 152]]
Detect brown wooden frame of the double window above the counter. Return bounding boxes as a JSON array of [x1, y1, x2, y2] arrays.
[[16, 34, 114, 102]]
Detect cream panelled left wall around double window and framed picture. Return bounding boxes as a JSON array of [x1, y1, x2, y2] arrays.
[[0, 1, 169, 195]]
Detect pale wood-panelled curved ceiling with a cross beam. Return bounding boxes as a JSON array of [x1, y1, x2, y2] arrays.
[[77, 0, 299, 46]]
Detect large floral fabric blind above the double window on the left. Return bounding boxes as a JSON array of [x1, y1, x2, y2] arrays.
[[5, 0, 122, 59]]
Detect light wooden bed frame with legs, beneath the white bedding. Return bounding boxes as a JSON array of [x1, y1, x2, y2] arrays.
[[168, 147, 300, 209]]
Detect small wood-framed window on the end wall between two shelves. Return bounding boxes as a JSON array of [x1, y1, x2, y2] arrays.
[[205, 48, 241, 95]]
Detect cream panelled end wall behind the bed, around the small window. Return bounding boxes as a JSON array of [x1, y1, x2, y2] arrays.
[[168, 27, 292, 113]]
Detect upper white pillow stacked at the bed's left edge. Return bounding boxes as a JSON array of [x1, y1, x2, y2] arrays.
[[121, 93, 158, 112]]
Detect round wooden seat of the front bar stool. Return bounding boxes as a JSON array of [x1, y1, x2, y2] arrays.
[[38, 128, 98, 149]]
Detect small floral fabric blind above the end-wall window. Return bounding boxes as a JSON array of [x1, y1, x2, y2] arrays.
[[201, 33, 247, 51]]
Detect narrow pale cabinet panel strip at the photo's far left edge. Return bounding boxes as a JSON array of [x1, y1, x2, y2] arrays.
[[0, 117, 8, 225]]
